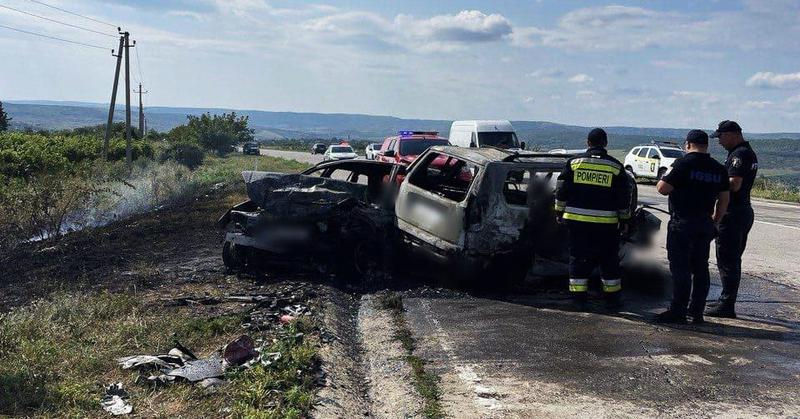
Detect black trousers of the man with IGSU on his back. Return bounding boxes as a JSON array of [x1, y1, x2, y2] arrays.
[[667, 217, 716, 314]]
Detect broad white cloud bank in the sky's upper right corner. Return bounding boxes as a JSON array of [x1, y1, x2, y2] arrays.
[[511, 1, 800, 52]]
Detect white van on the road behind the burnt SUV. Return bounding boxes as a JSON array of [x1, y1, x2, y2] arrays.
[[449, 120, 524, 149]]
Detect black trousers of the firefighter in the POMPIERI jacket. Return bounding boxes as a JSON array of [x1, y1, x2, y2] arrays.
[[567, 221, 621, 293]]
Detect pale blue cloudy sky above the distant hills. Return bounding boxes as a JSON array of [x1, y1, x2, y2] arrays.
[[0, 0, 800, 132]]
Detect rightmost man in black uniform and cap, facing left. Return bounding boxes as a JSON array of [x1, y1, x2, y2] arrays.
[[706, 120, 758, 319]]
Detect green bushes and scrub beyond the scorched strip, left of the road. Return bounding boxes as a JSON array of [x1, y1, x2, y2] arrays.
[[0, 113, 306, 256]]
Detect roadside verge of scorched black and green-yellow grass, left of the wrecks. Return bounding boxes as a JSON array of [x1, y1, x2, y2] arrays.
[[0, 184, 327, 417]]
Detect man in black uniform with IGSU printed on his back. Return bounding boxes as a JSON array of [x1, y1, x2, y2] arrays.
[[656, 130, 729, 324]]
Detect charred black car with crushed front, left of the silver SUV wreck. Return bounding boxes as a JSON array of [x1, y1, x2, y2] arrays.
[[218, 160, 403, 275]]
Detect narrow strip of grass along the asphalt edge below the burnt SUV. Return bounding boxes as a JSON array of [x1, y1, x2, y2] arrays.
[[377, 293, 445, 419]]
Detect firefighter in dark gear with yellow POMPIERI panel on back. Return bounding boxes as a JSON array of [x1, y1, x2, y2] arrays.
[[555, 128, 631, 308]]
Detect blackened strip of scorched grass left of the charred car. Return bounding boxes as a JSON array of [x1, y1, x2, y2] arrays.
[[0, 186, 245, 312]]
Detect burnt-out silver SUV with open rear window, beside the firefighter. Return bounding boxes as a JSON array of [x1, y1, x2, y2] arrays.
[[395, 146, 661, 285]]
